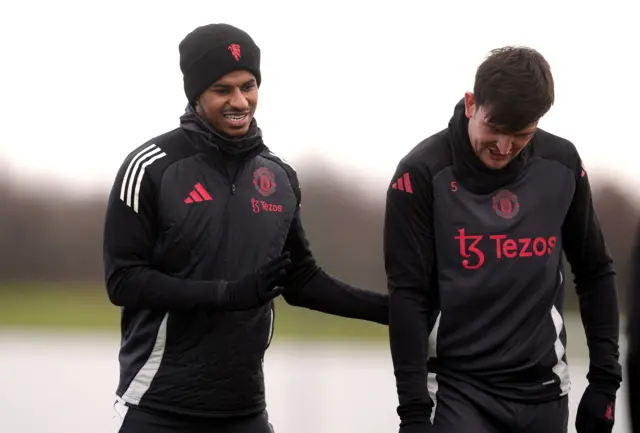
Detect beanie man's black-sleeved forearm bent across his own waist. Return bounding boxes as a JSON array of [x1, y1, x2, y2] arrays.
[[107, 266, 229, 311]]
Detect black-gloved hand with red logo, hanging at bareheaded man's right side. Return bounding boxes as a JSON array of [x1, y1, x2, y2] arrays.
[[576, 384, 616, 433]]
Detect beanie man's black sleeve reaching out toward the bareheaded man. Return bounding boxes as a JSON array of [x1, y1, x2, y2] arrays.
[[283, 189, 389, 325]]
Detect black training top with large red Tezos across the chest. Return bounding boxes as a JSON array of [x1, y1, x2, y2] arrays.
[[384, 101, 621, 423]]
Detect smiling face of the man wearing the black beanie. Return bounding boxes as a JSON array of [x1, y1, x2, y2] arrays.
[[196, 71, 258, 137]]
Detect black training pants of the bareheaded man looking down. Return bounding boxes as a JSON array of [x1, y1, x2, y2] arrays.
[[429, 374, 569, 433]]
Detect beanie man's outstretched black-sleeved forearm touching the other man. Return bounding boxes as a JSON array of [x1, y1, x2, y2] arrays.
[[283, 269, 389, 325]]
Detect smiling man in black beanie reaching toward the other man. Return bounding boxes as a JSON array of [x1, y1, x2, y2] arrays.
[[104, 24, 388, 433]]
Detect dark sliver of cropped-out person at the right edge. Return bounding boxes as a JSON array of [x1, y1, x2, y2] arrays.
[[626, 227, 640, 433]]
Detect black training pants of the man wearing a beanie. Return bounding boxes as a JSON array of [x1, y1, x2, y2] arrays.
[[112, 402, 273, 433]]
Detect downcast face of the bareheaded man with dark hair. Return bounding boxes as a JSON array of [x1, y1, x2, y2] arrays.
[[464, 92, 538, 170]]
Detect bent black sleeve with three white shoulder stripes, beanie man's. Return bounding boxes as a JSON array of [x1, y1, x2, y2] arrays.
[[103, 150, 227, 311]]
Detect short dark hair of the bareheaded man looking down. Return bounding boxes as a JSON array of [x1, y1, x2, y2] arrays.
[[473, 46, 555, 132]]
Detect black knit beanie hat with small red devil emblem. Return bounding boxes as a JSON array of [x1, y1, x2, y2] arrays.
[[178, 23, 261, 103]]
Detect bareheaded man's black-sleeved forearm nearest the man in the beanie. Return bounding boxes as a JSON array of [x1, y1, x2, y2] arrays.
[[389, 289, 433, 425]]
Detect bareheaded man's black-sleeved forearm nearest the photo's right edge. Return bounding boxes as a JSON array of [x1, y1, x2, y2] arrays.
[[577, 272, 622, 389]]
